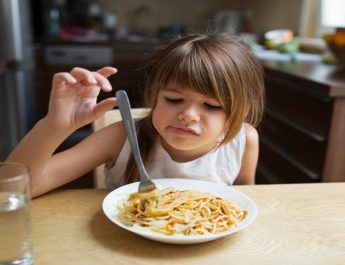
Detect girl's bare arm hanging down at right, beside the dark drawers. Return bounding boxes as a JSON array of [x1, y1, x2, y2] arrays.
[[234, 126, 259, 185]]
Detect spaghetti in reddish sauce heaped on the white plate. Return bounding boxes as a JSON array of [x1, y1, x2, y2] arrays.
[[118, 187, 248, 235]]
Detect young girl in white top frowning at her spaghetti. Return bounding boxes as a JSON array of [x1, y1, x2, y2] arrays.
[[7, 33, 264, 196]]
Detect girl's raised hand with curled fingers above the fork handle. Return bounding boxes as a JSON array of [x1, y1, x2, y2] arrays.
[[47, 67, 117, 130]]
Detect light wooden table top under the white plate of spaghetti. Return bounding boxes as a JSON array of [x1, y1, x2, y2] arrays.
[[32, 183, 345, 265]]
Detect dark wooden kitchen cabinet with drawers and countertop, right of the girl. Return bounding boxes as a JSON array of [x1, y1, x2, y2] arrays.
[[257, 60, 345, 183]]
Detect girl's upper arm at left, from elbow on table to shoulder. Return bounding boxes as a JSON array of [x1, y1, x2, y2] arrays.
[[31, 119, 126, 197]]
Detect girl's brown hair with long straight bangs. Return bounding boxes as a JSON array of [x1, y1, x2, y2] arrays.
[[125, 33, 264, 183]]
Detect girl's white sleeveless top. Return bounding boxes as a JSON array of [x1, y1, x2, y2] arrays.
[[105, 124, 246, 189]]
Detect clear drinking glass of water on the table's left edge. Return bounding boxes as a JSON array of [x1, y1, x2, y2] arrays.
[[0, 162, 33, 265]]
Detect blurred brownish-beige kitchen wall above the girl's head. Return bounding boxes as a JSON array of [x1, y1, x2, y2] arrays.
[[99, 0, 303, 34]]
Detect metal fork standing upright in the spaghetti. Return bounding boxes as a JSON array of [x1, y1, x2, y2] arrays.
[[116, 90, 157, 193]]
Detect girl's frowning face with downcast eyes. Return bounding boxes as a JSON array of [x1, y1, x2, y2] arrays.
[[152, 84, 226, 162]]
